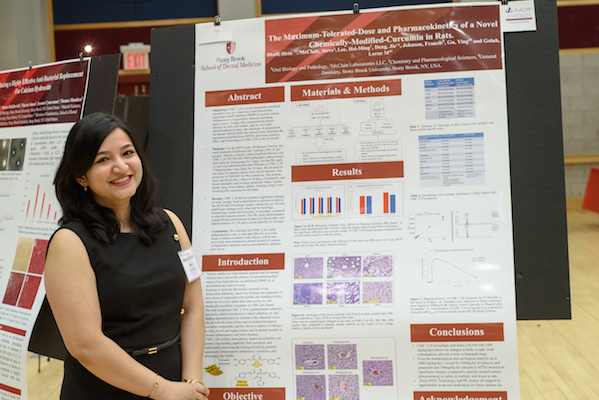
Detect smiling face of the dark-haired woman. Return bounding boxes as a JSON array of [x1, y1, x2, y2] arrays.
[[77, 128, 143, 210]]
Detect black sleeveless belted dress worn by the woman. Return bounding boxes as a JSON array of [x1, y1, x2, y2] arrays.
[[60, 217, 186, 400]]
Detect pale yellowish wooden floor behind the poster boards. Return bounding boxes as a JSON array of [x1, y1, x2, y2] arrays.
[[27, 211, 599, 400]]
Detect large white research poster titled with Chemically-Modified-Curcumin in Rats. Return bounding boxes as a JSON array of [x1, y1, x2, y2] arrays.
[[193, 4, 520, 400]]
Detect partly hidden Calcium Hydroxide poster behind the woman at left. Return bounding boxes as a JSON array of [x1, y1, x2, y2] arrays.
[[0, 60, 89, 400]]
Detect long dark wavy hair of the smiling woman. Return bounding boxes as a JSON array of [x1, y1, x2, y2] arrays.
[[54, 113, 168, 245]]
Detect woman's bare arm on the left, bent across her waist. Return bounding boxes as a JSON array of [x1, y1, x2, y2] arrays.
[[44, 229, 205, 399]]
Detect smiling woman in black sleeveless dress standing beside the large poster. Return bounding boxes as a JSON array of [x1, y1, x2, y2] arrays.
[[45, 113, 209, 400]]
